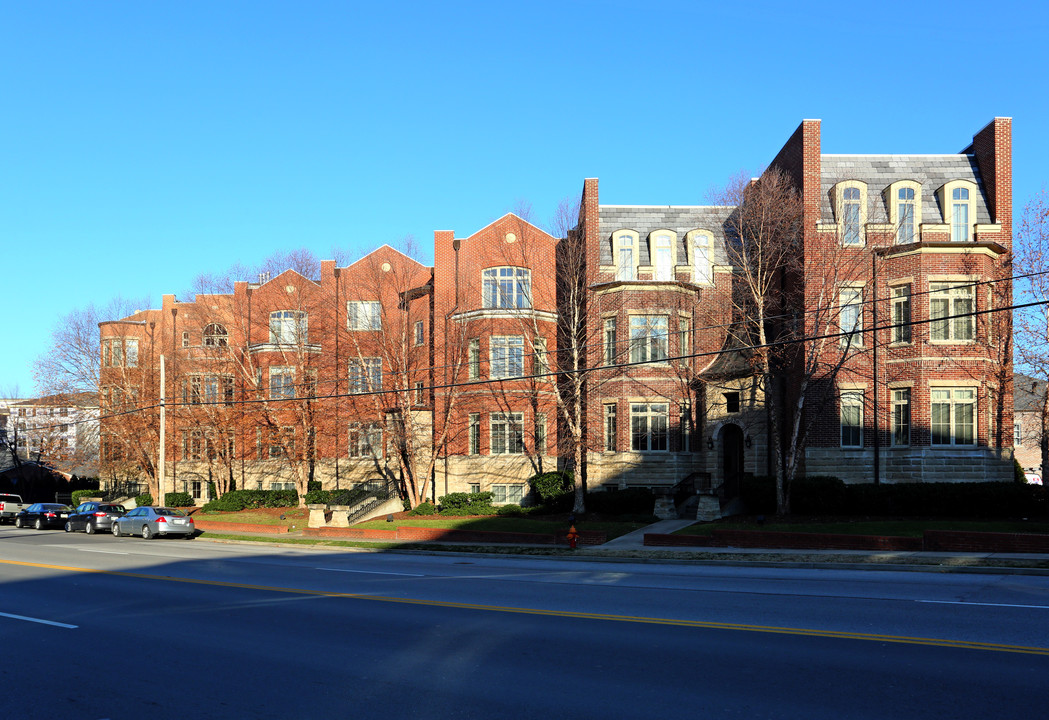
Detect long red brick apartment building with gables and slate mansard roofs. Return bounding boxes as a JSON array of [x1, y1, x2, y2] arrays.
[[100, 119, 1013, 510]]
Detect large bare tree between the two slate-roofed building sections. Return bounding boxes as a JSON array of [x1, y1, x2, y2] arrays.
[[719, 168, 876, 514]]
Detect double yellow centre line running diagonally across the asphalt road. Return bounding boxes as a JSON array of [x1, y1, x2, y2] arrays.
[[8, 559, 1049, 656]]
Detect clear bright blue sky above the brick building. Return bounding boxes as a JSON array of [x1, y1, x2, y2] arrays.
[[0, 0, 1049, 395]]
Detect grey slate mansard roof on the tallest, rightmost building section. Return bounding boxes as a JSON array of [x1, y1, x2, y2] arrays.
[[820, 155, 994, 224]]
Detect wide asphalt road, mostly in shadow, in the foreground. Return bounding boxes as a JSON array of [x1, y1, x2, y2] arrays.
[[0, 526, 1049, 720]]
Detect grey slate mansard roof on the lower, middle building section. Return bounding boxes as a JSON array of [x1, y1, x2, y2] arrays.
[[598, 205, 731, 264]]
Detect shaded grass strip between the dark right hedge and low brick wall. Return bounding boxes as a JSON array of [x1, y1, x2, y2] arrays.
[[673, 518, 1049, 537]]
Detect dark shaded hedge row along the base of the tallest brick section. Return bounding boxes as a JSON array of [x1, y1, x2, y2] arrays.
[[743, 478, 1049, 518]]
